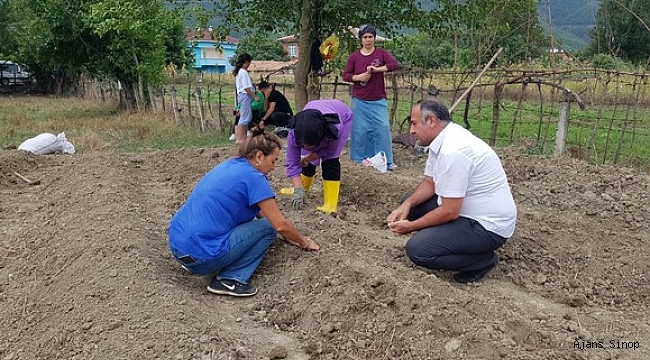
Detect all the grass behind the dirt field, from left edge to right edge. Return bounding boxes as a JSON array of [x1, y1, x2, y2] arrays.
[[5, 67, 650, 168]]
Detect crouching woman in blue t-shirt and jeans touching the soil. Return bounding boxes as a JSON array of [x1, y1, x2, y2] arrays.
[[168, 133, 320, 296]]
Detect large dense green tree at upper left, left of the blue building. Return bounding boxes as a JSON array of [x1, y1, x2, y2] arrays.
[[0, 0, 187, 107]]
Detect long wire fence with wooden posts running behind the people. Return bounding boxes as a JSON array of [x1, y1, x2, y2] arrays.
[[82, 68, 650, 167]]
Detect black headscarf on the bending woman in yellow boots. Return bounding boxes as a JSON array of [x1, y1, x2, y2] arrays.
[[287, 109, 341, 147]]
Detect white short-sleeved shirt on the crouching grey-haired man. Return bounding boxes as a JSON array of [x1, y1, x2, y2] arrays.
[[424, 123, 517, 238]]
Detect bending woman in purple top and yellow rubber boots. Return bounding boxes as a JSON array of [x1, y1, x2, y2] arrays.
[[282, 99, 352, 213]]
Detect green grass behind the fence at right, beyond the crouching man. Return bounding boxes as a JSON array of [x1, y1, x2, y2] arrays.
[[455, 100, 650, 163]]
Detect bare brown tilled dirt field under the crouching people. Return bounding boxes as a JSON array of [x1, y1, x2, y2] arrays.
[[0, 145, 650, 360]]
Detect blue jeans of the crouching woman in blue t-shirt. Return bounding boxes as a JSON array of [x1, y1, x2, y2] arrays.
[[172, 219, 278, 284]]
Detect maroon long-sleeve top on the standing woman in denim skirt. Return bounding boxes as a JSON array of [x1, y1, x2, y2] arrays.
[[343, 48, 401, 101]]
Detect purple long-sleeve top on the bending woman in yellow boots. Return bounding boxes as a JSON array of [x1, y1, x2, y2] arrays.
[[285, 99, 352, 179]]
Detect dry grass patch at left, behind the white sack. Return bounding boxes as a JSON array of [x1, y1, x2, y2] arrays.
[[0, 97, 231, 152]]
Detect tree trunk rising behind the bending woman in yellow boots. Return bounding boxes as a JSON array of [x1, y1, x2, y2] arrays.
[[293, 0, 312, 111]]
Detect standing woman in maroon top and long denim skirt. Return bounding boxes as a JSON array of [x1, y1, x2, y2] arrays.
[[343, 25, 400, 170]]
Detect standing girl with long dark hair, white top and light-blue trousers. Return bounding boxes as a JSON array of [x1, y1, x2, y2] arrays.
[[232, 53, 262, 144]]
